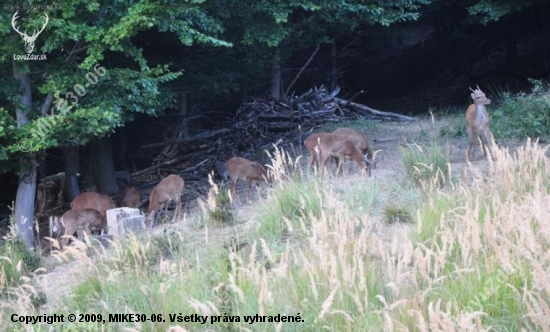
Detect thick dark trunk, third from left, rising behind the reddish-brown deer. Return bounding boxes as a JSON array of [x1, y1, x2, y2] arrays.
[[92, 137, 119, 195]]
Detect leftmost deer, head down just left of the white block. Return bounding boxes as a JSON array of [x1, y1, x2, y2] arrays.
[[50, 209, 107, 249]]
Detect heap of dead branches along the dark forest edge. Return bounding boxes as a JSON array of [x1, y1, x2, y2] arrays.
[[137, 86, 416, 179]]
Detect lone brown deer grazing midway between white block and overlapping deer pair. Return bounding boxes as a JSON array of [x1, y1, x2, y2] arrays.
[[225, 157, 271, 201]]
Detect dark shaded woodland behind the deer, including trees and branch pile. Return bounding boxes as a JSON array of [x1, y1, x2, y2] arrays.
[[0, 0, 550, 247]]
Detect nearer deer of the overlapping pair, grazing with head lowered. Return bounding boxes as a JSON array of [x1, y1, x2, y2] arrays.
[[319, 134, 372, 176]]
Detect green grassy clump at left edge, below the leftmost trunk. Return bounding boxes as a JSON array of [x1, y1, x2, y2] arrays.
[[0, 237, 41, 294]]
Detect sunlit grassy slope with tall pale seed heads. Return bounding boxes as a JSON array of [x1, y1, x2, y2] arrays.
[[0, 113, 550, 331]]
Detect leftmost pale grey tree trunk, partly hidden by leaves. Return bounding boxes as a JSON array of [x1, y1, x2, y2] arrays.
[[12, 60, 38, 249]]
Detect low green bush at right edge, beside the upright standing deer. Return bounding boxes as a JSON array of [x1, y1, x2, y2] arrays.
[[491, 80, 550, 138]]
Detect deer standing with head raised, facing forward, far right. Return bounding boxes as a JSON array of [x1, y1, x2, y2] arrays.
[[466, 86, 495, 161]]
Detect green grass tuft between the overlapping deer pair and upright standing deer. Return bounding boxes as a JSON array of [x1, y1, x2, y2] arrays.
[[401, 143, 449, 186]]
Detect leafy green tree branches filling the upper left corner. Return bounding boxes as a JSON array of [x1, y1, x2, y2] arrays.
[[0, 0, 231, 171]]
